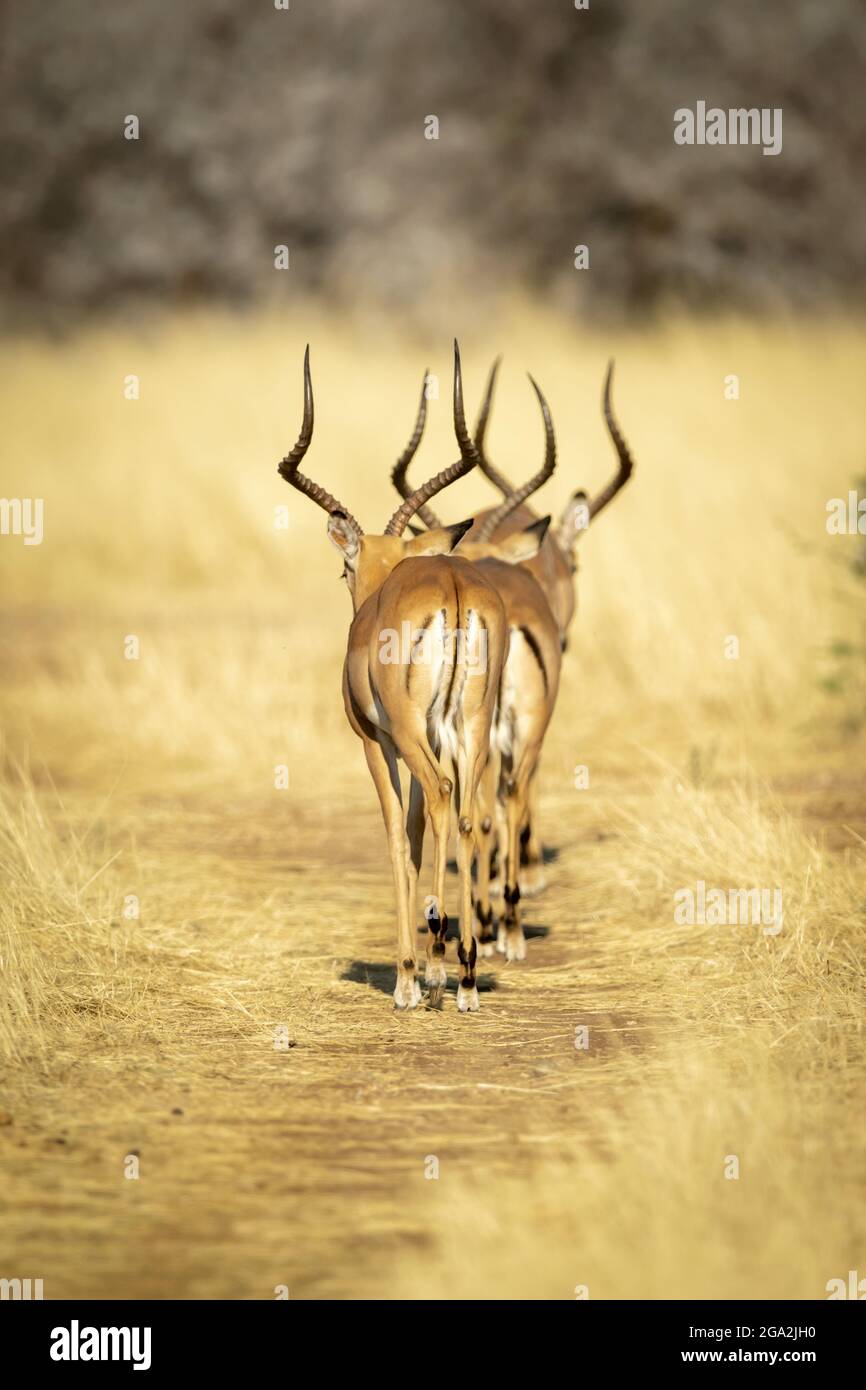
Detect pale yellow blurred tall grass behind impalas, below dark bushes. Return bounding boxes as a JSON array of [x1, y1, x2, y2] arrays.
[[0, 309, 863, 783]]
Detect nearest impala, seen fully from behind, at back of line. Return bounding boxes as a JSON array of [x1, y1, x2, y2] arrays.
[[279, 342, 507, 1012]]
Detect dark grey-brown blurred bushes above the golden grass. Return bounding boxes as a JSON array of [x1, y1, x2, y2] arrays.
[[0, 0, 866, 322]]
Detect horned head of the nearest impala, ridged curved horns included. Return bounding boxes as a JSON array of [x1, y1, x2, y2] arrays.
[[278, 341, 478, 610]]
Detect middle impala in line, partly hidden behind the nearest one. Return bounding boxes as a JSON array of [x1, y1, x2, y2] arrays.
[[392, 377, 562, 960]]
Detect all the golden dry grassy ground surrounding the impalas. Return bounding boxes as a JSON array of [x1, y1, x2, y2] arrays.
[[0, 310, 866, 1298]]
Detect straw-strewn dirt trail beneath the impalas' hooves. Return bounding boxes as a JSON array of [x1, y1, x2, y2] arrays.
[[0, 767, 671, 1298]]
